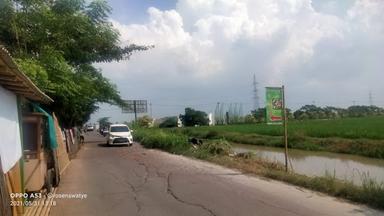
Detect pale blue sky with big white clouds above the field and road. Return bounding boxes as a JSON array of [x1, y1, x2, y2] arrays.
[[91, 0, 384, 122]]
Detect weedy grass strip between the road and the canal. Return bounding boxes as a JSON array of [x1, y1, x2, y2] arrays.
[[134, 128, 384, 209]]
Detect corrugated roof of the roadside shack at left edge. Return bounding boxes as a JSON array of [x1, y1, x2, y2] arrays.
[[0, 45, 53, 103]]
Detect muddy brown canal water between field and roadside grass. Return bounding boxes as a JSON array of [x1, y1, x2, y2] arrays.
[[233, 144, 384, 185]]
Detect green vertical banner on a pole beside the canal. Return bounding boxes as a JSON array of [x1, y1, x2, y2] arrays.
[[265, 87, 283, 124]]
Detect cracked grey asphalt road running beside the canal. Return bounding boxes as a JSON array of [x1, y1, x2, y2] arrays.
[[50, 133, 383, 216]]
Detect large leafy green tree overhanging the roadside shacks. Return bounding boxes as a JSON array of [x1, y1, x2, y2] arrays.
[[0, 0, 151, 127]]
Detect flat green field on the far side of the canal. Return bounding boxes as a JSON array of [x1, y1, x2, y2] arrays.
[[169, 116, 384, 159]]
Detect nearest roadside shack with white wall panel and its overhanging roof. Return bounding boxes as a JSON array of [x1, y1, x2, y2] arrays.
[[0, 45, 53, 215]]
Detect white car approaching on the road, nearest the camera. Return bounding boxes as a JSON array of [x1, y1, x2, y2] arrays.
[[107, 124, 133, 146]]
